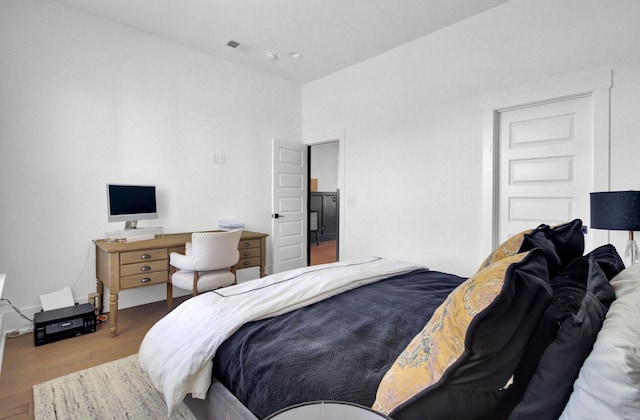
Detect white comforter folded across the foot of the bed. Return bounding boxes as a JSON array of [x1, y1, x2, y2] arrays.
[[139, 258, 424, 415]]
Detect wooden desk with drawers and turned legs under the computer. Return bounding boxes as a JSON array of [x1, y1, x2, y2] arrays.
[[95, 230, 269, 337]]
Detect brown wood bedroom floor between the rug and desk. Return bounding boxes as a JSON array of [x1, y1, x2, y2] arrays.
[[0, 297, 185, 420]]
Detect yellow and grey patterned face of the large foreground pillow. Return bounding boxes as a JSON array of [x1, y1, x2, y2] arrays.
[[373, 253, 529, 414]]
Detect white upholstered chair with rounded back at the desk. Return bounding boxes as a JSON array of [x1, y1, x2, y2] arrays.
[[167, 230, 242, 306]]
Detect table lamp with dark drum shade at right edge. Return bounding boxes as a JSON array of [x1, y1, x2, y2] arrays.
[[589, 191, 640, 266]]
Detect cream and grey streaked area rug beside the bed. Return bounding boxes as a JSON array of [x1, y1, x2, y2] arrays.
[[33, 354, 195, 420]]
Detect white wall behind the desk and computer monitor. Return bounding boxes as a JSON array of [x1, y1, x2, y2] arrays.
[[0, 0, 302, 328]]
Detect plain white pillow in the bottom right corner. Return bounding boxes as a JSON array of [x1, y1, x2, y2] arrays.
[[560, 264, 640, 420]]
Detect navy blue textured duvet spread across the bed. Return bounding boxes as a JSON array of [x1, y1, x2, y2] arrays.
[[214, 270, 466, 418]]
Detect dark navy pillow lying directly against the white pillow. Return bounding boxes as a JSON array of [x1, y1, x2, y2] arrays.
[[504, 250, 615, 419]]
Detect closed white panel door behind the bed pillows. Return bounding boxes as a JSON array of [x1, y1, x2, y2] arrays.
[[498, 96, 593, 242]]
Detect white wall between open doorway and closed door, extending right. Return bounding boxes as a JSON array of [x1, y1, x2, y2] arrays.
[[303, 0, 640, 275]]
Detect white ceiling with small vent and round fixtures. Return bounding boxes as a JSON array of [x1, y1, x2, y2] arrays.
[[55, 0, 508, 84]]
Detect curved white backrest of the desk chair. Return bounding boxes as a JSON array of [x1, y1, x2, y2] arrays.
[[191, 230, 242, 271]]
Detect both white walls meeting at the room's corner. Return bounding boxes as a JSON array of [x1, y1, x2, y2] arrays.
[[0, 0, 640, 334]]
